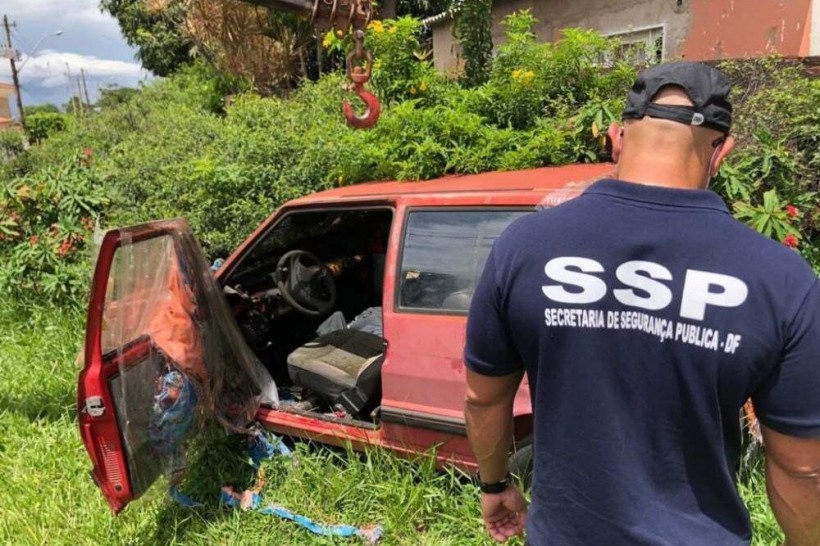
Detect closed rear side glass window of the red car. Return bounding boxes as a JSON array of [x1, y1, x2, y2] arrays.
[[399, 209, 530, 312]]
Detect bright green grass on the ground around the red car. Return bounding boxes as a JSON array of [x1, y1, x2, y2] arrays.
[[0, 301, 782, 546]]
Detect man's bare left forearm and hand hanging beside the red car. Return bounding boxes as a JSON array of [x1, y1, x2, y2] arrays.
[[464, 369, 527, 542]]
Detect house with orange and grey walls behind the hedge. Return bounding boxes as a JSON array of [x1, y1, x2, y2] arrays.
[[431, 0, 820, 72]]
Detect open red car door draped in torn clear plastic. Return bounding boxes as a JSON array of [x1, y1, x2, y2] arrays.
[[77, 220, 276, 513]]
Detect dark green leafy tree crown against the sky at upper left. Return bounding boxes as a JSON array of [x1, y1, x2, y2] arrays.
[[100, 0, 194, 76]]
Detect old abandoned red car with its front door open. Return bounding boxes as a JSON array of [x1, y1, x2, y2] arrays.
[[77, 164, 613, 512]]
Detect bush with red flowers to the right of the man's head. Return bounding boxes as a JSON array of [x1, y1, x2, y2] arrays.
[[714, 57, 820, 271]]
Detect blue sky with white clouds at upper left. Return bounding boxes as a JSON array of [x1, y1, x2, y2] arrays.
[[0, 0, 151, 110]]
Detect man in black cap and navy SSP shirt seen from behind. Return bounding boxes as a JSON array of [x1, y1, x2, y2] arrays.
[[465, 62, 820, 546]]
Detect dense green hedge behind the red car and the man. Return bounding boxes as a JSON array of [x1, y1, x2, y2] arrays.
[[0, 12, 820, 306]]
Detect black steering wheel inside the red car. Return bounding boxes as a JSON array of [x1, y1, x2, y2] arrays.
[[273, 250, 336, 317]]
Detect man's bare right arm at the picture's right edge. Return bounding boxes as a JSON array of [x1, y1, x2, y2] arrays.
[[760, 424, 820, 546]]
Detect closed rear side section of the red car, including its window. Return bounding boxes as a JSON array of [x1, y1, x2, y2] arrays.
[[381, 206, 532, 440]]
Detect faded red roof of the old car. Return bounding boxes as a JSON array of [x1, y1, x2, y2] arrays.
[[289, 163, 615, 205]]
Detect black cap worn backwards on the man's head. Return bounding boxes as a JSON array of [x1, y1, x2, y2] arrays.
[[623, 61, 732, 133]]
